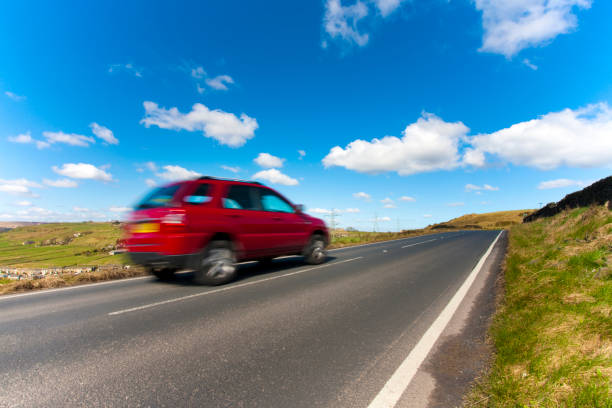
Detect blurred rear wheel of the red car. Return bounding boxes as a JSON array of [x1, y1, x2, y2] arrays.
[[193, 241, 237, 286]]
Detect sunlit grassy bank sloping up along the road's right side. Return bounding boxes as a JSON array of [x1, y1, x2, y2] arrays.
[[467, 207, 612, 407]]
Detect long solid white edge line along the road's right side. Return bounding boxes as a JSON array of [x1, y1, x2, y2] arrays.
[[368, 231, 503, 408]]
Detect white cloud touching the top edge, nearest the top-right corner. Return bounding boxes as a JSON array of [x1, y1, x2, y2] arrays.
[[475, 0, 592, 58]]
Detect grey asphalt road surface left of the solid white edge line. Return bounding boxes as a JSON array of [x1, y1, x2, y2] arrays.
[[0, 231, 498, 407]]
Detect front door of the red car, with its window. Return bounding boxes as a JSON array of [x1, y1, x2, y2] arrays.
[[258, 188, 308, 253]]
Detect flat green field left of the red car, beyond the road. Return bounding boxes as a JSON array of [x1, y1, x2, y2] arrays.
[[0, 222, 125, 268]]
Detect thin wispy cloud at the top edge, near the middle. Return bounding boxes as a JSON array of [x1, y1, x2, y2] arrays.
[[323, 0, 369, 47]]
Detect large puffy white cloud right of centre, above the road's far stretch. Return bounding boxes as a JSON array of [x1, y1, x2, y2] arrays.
[[323, 113, 469, 175]]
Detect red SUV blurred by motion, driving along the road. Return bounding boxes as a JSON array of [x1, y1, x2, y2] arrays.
[[124, 177, 329, 285]]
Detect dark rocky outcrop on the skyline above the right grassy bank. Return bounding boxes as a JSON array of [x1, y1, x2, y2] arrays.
[[523, 176, 612, 222]]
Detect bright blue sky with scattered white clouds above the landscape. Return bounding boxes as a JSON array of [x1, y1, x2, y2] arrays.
[[0, 0, 612, 230]]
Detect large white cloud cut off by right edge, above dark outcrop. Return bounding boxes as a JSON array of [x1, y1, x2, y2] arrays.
[[470, 103, 612, 170]]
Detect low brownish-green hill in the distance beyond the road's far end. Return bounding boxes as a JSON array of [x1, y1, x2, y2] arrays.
[[426, 210, 534, 230]]
